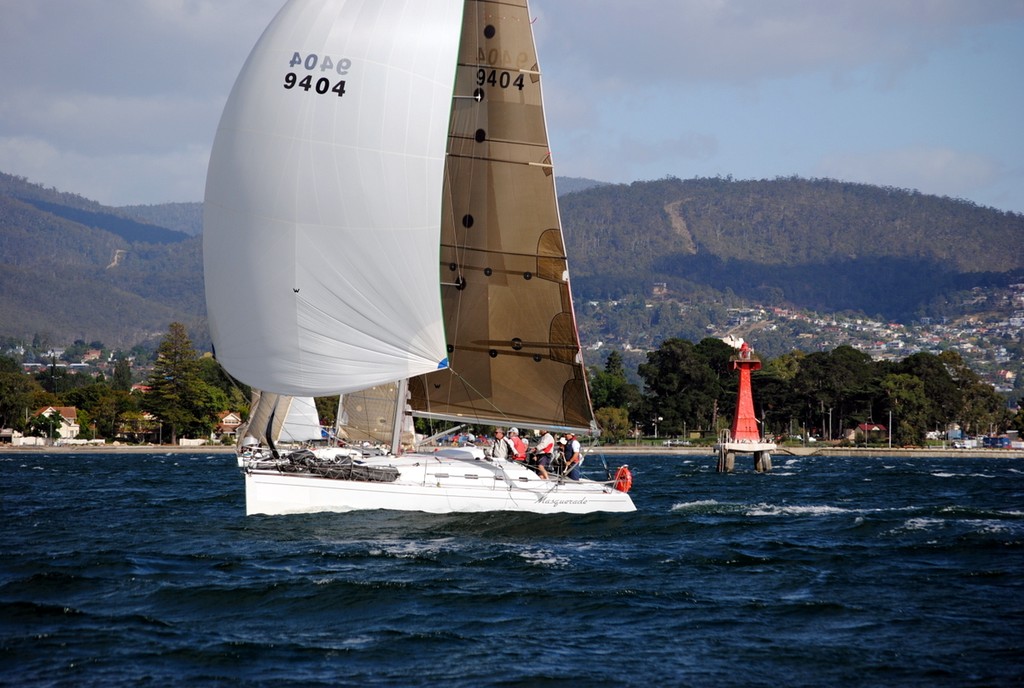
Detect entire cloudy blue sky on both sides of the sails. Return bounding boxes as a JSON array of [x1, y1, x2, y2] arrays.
[[0, 0, 1024, 213]]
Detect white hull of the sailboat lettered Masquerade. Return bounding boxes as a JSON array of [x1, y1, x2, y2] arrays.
[[245, 449, 636, 515]]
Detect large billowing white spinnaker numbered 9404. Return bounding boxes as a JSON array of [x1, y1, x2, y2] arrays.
[[204, 0, 463, 396]]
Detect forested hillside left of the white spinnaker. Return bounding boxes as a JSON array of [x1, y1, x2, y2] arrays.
[[0, 174, 203, 349]]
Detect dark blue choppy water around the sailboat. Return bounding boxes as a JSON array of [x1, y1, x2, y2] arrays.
[[0, 453, 1024, 687]]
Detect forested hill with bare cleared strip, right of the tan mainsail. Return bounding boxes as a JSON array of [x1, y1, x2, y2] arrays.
[[560, 178, 1024, 319]]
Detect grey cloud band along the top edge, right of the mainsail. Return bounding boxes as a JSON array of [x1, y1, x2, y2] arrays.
[[532, 0, 1024, 87]]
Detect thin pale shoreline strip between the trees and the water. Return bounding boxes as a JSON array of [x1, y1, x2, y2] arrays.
[[0, 444, 1024, 459]]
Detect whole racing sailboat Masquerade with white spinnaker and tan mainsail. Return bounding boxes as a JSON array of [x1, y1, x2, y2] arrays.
[[204, 0, 635, 515]]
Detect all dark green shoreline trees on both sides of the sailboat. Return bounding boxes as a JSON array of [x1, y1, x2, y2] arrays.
[[0, 323, 1024, 444]]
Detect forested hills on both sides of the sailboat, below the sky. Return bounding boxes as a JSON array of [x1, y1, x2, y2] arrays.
[[0, 173, 1024, 348]]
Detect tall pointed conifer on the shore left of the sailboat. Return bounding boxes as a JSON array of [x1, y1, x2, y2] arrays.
[[142, 323, 215, 444]]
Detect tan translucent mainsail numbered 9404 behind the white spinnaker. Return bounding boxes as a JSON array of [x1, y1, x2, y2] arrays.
[[410, 1, 593, 430]]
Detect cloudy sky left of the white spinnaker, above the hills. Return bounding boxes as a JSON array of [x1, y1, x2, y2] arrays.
[[0, 0, 282, 205]]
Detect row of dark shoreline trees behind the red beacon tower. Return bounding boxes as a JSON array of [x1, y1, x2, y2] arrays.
[[590, 339, 1024, 445]]
